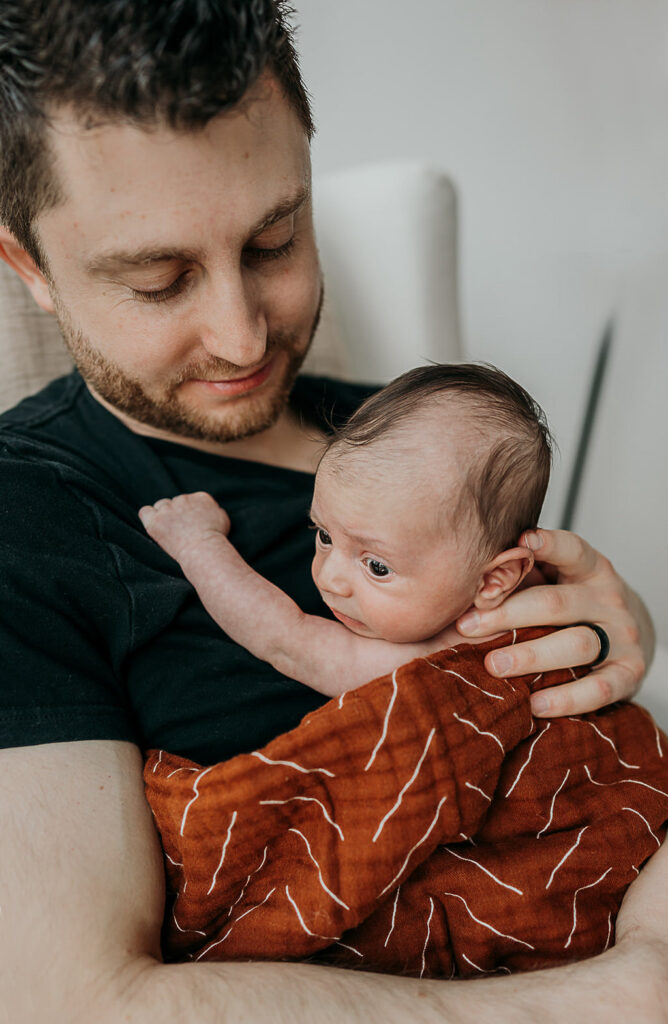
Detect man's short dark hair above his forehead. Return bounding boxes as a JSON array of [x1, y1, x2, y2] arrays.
[[0, 0, 314, 268]]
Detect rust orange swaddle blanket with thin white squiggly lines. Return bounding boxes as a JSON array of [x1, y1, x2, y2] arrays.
[[144, 630, 668, 977]]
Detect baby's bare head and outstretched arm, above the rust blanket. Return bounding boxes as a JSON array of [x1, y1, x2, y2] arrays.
[[139, 365, 550, 696]]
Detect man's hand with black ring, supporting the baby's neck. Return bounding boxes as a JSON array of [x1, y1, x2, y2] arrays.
[[457, 529, 655, 718]]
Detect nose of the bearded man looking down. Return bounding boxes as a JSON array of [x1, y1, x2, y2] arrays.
[[200, 274, 267, 367]]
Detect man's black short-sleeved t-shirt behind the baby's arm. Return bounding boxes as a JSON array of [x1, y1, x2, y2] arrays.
[[0, 372, 372, 764]]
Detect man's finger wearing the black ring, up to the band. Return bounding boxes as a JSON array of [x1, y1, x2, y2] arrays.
[[485, 626, 600, 678]]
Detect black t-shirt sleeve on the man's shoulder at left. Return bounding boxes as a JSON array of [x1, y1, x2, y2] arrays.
[[0, 446, 137, 746]]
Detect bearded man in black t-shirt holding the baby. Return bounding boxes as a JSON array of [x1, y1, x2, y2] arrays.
[[0, 0, 668, 1024]]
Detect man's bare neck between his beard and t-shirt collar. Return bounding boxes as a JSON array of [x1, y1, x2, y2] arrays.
[[87, 385, 325, 473]]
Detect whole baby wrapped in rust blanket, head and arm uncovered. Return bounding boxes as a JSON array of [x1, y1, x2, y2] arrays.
[[139, 365, 668, 976]]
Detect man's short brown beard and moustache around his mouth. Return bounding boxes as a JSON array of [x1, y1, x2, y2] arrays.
[[56, 291, 323, 442]]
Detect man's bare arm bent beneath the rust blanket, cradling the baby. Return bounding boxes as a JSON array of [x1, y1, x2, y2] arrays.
[[0, 740, 668, 1024]]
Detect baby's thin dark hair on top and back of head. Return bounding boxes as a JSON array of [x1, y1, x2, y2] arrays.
[[325, 362, 552, 558]]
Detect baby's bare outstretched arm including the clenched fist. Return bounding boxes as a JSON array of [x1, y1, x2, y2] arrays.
[[139, 492, 428, 696]]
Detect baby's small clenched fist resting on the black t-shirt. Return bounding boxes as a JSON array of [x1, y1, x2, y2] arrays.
[[139, 490, 231, 563]]
